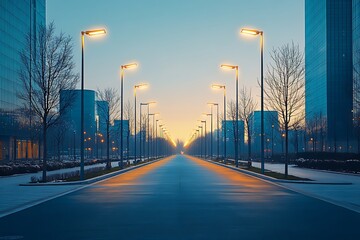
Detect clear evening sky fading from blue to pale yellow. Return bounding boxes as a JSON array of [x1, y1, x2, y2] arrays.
[[47, 0, 305, 141]]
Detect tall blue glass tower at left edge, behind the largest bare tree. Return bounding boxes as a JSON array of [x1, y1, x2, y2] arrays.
[[0, 0, 46, 160]]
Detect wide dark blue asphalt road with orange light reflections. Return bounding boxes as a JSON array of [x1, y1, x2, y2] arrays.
[[0, 155, 360, 240]]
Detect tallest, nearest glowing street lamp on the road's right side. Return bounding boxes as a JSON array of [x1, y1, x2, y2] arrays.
[[240, 28, 264, 174]]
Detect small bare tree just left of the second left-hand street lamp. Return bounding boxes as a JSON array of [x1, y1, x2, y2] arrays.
[[97, 88, 120, 169]]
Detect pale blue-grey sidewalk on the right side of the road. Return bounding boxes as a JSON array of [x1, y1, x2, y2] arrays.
[[253, 162, 360, 213]]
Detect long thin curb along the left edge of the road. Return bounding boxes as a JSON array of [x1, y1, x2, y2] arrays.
[[19, 158, 165, 187]]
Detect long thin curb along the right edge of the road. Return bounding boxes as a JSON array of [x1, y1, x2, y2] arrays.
[[200, 158, 352, 185]]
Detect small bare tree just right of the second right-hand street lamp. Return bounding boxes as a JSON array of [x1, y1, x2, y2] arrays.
[[239, 87, 256, 167]]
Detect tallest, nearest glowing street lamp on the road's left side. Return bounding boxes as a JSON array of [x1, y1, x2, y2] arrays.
[[80, 29, 106, 180]]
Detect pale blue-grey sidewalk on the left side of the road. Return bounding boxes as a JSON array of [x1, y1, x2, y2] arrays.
[[0, 162, 118, 217]]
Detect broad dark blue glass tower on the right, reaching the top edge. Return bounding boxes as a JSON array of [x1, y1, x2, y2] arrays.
[[305, 0, 353, 151]]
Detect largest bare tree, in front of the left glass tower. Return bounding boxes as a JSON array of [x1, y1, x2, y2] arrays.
[[18, 23, 79, 181]]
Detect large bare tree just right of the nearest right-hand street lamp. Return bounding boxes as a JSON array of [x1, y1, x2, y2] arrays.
[[265, 43, 305, 177]]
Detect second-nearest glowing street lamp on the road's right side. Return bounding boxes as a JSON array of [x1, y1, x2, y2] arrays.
[[220, 64, 239, 167]]
